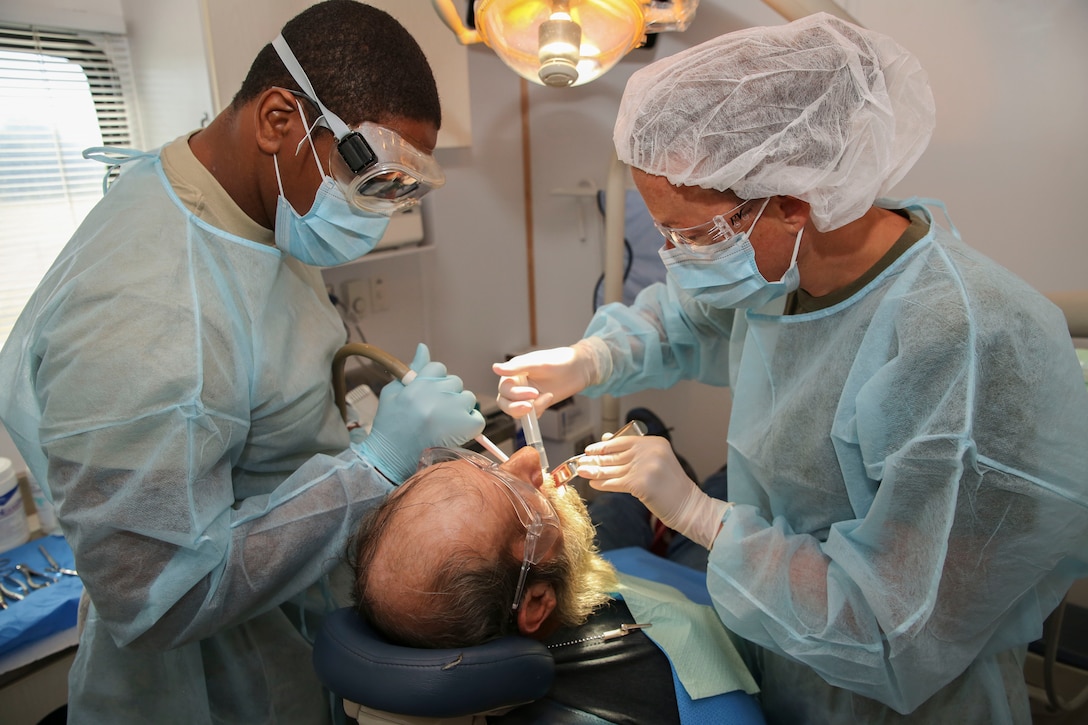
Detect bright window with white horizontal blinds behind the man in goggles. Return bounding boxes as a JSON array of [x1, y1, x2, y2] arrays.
[[0, 23, 139, 345]]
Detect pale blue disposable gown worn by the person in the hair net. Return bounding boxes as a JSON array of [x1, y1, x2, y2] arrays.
[[585, 201, 1088, 724]]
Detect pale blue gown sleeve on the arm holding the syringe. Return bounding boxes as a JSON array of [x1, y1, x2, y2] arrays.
[[583, 278, 734, 397]]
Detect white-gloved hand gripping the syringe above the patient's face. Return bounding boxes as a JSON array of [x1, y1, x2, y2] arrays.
[[491, 340, 601, 418]]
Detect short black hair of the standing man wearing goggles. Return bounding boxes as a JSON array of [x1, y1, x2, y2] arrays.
[[231, 0, 442, 126]]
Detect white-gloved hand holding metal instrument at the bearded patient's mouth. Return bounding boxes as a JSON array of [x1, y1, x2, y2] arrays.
[[578, 435, 733, 549]]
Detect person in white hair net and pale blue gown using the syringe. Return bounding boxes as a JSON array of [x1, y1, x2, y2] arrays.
[[495, 14, 1088, 724]]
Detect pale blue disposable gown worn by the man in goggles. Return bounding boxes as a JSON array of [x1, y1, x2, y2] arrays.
[[0, 149, 391, 725]]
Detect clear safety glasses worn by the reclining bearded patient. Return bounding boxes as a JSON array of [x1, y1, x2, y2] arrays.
[[418, 447, 560, 611]]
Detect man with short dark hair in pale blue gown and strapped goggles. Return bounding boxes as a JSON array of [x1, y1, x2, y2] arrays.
[[0, 0, 483, 725]]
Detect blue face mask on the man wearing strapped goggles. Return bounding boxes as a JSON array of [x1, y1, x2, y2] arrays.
[[272, 106, 390, 267]]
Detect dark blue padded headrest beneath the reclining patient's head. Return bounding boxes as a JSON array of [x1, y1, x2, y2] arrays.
[[313, 609, 555, 717]]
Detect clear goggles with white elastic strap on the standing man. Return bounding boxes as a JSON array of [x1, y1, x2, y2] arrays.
[[272, 35, 446, 214]]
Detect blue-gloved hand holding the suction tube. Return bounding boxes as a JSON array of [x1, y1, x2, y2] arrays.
[[353, 343, 484, 484]]
